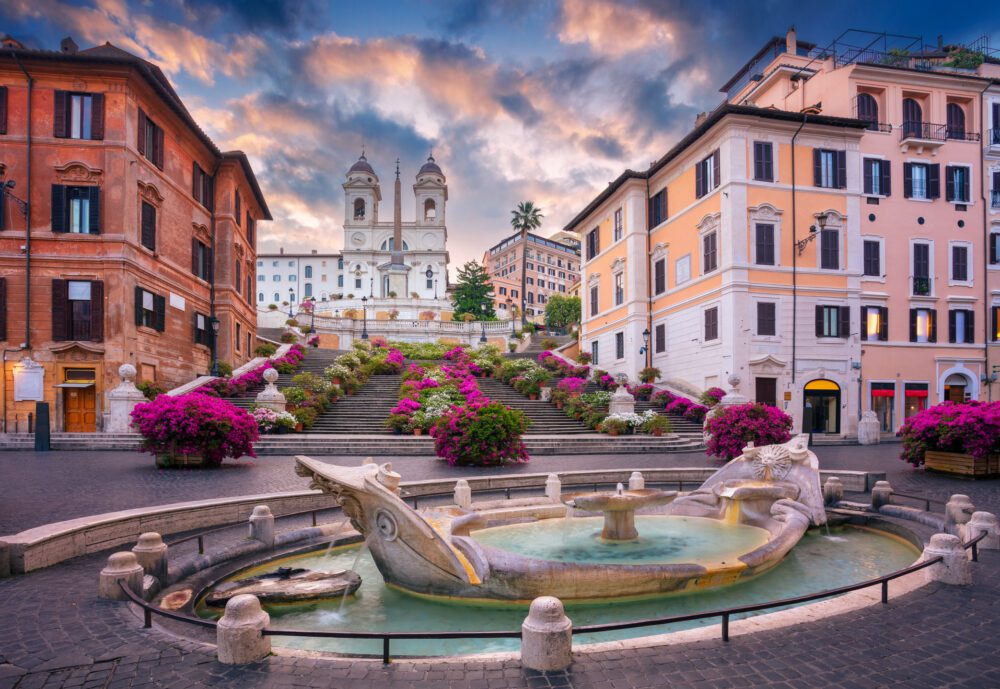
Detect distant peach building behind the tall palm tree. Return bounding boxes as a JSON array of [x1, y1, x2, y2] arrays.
[[483, 232, 580, 323]]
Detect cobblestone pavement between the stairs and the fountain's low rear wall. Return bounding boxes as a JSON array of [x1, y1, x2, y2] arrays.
[[0, 443, 920, 534]]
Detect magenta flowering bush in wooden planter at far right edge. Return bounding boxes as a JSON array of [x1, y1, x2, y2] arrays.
[[896, 400, 1000, 467]]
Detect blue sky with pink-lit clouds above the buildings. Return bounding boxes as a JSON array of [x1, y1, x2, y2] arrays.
[[0, 0, 1000, 277]]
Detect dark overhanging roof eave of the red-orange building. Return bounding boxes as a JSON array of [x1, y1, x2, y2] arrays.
[[0, 42, 272, 220]]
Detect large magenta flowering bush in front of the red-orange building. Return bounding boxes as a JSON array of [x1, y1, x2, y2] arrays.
[[132, 393, 259, 466]]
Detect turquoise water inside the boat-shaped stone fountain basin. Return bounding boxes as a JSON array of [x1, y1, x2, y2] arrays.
[[472, 515, 768, 567]]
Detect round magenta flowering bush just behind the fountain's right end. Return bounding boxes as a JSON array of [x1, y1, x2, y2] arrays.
[[705, 402, 792, 459]]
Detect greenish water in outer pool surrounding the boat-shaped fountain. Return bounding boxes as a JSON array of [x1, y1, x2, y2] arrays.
[[199, 520, 919, 656]]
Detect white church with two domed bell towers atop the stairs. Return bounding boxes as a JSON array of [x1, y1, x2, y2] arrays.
[[343, 153, 448, 299]]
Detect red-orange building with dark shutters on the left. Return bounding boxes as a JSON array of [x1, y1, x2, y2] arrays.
[[0, 39, 270, 432]]
